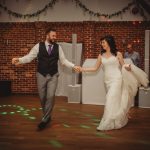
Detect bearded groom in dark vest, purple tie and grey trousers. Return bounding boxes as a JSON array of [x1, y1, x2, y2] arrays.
[[12, 29, 80, 130]]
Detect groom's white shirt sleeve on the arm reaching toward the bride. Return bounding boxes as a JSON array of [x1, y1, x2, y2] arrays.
[[59, 45, 75, 68]]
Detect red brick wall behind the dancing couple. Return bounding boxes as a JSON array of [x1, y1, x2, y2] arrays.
[[0, 22, 150, 93]]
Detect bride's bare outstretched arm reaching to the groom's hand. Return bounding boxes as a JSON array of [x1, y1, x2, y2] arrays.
[[81, 54, 102, 72]]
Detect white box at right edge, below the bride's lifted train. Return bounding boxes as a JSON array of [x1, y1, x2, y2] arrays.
[[139, 87, 150, 108]]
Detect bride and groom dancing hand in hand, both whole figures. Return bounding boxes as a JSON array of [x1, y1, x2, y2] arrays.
[[12, 29, 148, 130]]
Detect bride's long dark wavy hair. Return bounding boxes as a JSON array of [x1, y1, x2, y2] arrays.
[[100, 35, 118, 56]]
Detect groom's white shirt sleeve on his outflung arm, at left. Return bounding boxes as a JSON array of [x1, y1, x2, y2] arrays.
[[19, 43, 39, 64]]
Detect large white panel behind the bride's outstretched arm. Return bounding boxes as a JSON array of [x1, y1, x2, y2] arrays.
[[82, 59, 106, 105]]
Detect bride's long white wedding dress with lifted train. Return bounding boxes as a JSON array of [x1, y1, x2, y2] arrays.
[[97, 56, 149, 130]]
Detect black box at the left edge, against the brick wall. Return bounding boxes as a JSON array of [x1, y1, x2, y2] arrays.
[[0, 81, 11, 96]]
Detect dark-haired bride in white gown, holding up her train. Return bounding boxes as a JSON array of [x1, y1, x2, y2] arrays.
[[81, 36, 148, 130]]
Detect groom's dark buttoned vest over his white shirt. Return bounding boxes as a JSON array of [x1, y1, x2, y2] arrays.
[[37, 42, 59, 76]]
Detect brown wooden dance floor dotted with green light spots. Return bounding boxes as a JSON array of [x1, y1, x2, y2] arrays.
[[0, 95, 150, 150]]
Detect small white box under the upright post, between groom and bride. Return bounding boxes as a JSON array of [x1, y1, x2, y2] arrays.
[[68, 84, 81, 103]]
